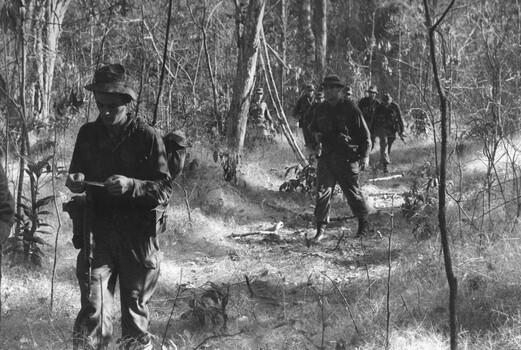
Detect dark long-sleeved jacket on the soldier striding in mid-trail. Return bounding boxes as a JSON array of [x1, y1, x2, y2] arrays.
[[309, 99, 371, 160]]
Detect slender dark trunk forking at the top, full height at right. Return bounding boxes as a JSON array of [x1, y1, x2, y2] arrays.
[[423, 0, 458, 350]]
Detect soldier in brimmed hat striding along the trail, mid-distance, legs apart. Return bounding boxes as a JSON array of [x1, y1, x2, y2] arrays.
[[309, 75, 371, 242]]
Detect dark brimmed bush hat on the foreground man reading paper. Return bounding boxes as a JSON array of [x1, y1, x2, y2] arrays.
[[85, 63, 137, 100]]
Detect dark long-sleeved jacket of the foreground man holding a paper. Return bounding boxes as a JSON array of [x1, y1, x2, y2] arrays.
[[69, 117, 172, 215]]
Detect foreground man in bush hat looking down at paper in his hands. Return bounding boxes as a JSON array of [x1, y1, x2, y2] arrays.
[[66, 64, 172, 349]]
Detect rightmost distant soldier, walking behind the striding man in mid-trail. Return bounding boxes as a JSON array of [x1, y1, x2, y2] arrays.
[[370, 94, 404, 173]]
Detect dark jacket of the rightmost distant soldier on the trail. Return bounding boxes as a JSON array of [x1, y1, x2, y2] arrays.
[[370, 102, 404, 136]]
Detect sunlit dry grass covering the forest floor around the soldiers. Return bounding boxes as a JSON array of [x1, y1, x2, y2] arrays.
[[0, 133, 521, 350]]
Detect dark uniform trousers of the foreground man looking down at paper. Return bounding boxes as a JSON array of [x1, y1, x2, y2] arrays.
[[73, 218, 160, 349]]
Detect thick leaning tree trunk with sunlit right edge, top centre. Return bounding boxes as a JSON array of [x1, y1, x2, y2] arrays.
[[226, 0, 266, 156]]
